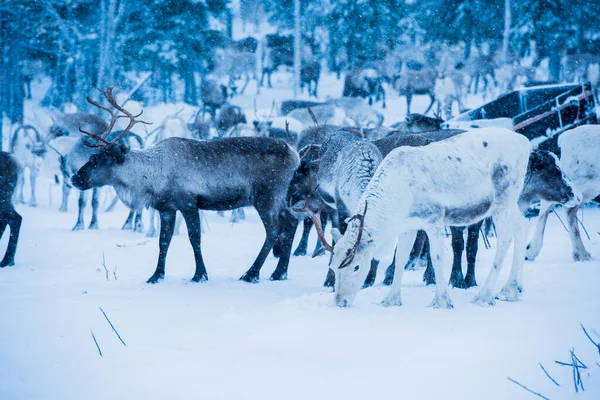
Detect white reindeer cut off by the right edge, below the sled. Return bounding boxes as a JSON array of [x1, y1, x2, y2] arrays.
[[526, 125, 600, 261]]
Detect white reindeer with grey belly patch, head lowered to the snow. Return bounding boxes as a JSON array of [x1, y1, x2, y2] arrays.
[[331, 128, 531, 308]]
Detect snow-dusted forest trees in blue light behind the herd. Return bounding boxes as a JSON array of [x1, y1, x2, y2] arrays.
[[0, 0, 600, 127]]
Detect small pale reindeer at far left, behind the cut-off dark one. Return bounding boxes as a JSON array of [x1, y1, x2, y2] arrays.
[[10, 125, 47, 207]]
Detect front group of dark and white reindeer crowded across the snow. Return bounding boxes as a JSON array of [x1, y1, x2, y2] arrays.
[[0, 83, 600, 308]]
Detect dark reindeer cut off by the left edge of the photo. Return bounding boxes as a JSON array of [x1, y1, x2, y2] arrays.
[[0, 151, 23, 268]]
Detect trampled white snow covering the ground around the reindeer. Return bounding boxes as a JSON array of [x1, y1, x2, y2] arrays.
[[0, 73, 600, 400]]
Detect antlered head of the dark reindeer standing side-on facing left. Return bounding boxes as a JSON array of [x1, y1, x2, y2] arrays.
[[71, 87, 149, 190]]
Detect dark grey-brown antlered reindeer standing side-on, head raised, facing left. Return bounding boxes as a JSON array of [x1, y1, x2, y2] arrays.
[[72, 88, 299, 283]]
